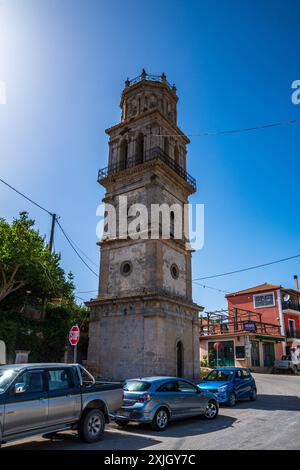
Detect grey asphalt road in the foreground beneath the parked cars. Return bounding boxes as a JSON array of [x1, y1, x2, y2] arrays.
[[2, 374, 300, 450]]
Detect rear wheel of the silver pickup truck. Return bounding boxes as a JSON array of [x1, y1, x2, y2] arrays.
[[78, 409, 105, 442]]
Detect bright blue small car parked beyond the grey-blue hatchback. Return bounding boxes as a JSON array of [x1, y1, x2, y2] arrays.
[[199, 367, 257, 406]]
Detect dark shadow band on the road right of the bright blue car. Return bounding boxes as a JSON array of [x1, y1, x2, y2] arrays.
[[237, 394, 300, 411]]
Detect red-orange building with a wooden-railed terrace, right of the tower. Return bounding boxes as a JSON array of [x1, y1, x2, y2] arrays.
[[200, 276, 300, 371]]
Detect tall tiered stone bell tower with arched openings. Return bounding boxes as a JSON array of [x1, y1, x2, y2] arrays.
[[87, 70, 202, 380]]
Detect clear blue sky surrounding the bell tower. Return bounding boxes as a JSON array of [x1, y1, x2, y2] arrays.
[[0, 0, 300, 309]]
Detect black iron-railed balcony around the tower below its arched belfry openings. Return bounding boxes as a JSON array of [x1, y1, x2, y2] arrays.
[[98, 147, 196, 191]]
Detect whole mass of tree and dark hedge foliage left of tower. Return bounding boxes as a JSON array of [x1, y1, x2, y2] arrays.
[[0, 212, 88, 362]]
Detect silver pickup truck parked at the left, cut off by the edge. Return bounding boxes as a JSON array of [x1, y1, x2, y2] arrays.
[[0, 364, 123, 445]]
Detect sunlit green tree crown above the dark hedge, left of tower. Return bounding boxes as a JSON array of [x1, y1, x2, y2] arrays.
[[0, 212, 74, 310]]
